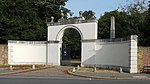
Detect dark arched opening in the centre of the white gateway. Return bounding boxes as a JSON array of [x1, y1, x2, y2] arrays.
[[61, 28, 81, 66]]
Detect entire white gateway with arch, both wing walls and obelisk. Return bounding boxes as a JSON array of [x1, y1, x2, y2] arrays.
[[8, 12, 138, 73]]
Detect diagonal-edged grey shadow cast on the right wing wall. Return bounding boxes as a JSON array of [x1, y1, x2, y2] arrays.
[[83, 41, 130, 71]]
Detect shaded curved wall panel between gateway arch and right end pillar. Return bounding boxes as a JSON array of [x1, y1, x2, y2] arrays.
[[95, 41, 130, 67]]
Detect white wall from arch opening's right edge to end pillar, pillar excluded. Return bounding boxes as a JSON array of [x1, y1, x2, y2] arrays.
[[82, 40, 130, 68]]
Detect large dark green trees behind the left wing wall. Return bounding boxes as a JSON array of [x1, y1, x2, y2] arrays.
[[0, 0, 67, 43]]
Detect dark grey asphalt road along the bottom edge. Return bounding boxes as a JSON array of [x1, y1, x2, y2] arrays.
[[0, 76, 150, 84]]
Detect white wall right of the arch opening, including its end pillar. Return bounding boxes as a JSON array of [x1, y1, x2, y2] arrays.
[[81, 35, 137, 73]]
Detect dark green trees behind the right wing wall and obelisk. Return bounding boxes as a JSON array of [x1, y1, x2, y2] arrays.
[[98, 2, 150, 46]]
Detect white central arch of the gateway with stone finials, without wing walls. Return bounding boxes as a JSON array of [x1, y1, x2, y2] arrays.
[[47, 14, 98, 65]]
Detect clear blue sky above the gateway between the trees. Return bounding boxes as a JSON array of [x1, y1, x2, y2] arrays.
[[65, 0, 135, 18]]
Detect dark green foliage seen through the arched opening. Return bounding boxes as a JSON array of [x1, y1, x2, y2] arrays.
[[63, 29, 81, 57]]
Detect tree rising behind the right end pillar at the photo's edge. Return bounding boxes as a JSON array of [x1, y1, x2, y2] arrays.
[[122, 0, 150, 46]]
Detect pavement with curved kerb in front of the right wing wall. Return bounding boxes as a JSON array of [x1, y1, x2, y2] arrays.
[[68, 70, 150, 80]]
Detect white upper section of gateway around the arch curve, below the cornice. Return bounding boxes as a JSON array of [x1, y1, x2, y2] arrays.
[[48, 21, 97, 41]]
